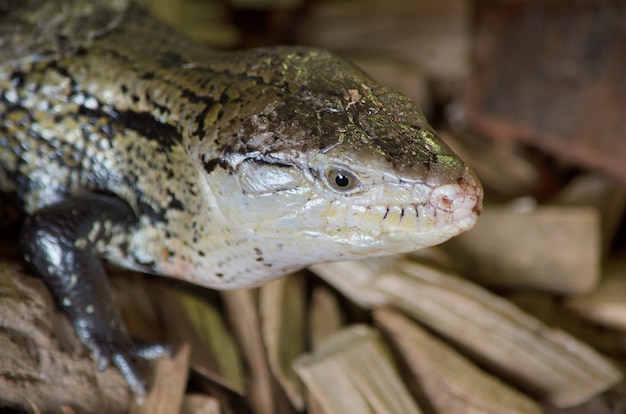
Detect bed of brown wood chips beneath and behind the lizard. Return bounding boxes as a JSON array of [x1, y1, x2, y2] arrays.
[[0, 0, 626, 414]]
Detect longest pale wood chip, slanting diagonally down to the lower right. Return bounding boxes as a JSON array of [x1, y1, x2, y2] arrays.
[[372, 261, 622, 407]]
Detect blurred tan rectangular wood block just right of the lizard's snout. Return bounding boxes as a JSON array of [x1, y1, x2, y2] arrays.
[[443, 206, 602, 295]]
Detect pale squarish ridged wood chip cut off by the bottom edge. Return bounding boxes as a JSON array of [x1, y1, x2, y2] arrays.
[[294, 325, 421, 414]]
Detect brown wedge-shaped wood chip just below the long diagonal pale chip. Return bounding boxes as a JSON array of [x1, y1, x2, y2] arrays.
[[374, 308, 541, 414]]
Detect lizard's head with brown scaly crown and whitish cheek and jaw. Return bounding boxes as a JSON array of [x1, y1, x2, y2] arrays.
[[193, 48, 483, 284]]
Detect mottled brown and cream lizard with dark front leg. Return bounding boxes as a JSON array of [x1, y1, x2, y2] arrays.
[[0, 0, 483, 395]]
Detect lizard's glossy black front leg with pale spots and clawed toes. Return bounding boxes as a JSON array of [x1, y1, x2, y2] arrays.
[[21, 194, 167, 396]]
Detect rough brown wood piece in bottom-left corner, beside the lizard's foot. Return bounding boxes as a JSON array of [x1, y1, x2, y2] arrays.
[[0, 259, 130, 413]]
